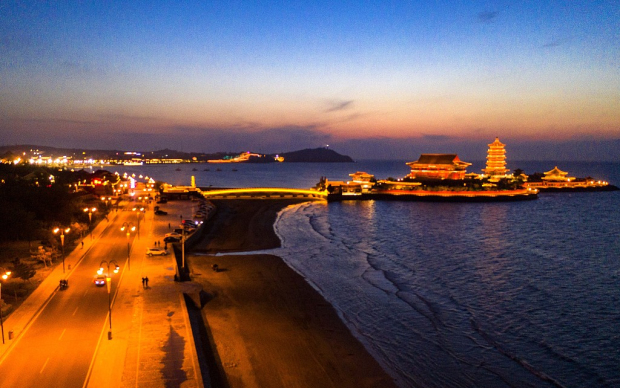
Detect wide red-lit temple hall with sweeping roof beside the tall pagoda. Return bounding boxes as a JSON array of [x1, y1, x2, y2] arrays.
[[407, 154, 471, 179]]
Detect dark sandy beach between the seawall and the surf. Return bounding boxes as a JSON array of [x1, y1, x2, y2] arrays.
[[188, 199, 395, 387]]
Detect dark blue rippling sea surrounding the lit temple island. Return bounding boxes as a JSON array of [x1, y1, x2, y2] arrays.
[[108, 161, 620, 387]]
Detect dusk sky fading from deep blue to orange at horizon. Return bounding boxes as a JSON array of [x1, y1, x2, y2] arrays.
[[0, 0, 620, 161]]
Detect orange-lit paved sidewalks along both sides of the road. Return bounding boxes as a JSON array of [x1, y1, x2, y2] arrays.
[[0, 196, 204, 388]]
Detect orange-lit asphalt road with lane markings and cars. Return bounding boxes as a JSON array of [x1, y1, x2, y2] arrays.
[[0, 205, 136, 388]]
